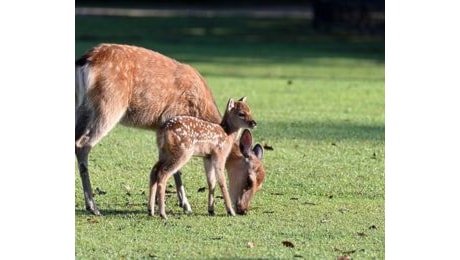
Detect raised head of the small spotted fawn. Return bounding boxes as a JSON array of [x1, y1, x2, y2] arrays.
[[223, 97, 257, 131]]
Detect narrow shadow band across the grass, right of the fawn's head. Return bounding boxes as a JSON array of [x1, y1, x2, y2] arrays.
[[255, 121, 385, 141]]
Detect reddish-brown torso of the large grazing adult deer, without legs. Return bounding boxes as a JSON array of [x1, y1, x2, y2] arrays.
[[82, 44, 221, 131]]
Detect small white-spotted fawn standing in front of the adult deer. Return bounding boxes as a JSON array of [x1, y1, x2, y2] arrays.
[[148, 97, 256, 219]]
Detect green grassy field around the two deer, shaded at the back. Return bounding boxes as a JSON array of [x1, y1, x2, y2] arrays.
[[75, 12, 385, 259]]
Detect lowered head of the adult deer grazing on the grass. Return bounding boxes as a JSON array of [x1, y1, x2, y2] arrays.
[[225, 129, 265, 215]]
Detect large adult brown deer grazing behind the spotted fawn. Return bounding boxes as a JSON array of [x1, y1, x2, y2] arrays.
[[75, 44, 265, 215]]
